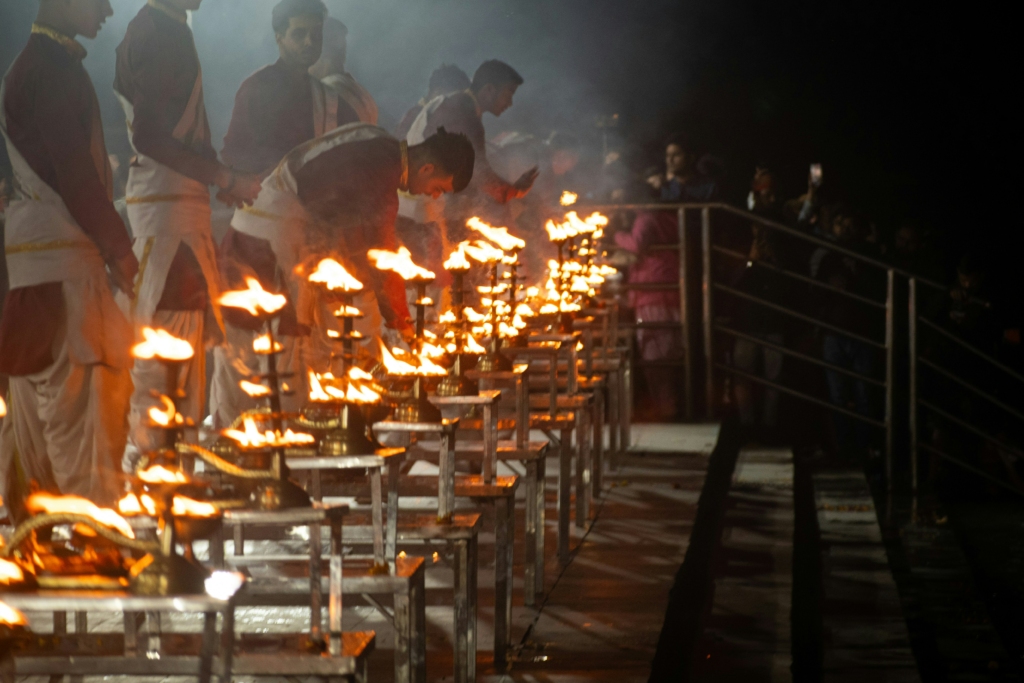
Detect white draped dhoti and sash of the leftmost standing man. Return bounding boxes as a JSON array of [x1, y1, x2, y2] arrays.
[[0, 81, 131, 505]]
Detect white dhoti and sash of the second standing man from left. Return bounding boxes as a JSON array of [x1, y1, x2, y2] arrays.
[[118, 65, 223, 464]]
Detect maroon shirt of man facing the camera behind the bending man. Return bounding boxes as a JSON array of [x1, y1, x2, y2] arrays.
[[220, 59, 359, 176]]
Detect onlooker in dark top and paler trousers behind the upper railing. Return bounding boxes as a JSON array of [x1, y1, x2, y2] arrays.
[[732, 224, 787, 438]]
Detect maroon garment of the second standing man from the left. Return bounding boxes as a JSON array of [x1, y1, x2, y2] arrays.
[[114, 5, 220, 310]]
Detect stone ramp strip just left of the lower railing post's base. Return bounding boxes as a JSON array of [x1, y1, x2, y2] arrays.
[[814, 470, 921, 683]]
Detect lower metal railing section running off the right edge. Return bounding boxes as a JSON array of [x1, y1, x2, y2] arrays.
[[907, 278, 1024, 507]]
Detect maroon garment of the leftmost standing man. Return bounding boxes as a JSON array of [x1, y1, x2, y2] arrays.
[[0, 34, 131, 375]]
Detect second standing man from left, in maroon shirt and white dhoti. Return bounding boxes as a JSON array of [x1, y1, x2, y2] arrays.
[[114, 0, 259, 467]]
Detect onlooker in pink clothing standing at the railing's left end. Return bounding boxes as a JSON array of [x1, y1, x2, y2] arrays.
[[614, 211, 682, 420]]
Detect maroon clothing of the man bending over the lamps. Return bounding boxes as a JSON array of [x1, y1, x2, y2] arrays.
[[220, 137, 409, 332]]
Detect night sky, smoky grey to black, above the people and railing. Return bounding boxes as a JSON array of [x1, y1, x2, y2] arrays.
[[0, 0, 1019, 266]]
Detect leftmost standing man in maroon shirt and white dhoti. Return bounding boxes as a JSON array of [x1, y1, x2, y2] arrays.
[[0, 0, 138, 505]]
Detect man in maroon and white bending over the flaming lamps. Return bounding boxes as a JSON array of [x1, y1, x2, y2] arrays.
[[210, 123, 474, 428]]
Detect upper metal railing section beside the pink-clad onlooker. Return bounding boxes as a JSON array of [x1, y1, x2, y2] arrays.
[[585, 198, 941, 486]]
